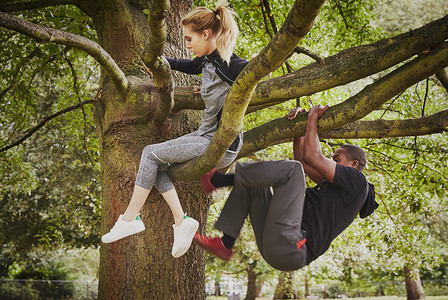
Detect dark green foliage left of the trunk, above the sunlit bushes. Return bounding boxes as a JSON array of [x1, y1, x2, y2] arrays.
[[0, 6, 101, 275]]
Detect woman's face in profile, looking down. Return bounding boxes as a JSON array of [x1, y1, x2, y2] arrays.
[[183, 25, 216, 57]]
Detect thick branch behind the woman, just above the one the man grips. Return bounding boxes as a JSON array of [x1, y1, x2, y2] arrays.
[[171, 16, 448, 112]]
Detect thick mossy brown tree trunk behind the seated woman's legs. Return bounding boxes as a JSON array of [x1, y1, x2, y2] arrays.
[[93, 1, 210, 300]]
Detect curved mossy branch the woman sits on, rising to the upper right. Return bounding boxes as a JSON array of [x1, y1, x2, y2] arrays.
[[169, 0, 324, 180]]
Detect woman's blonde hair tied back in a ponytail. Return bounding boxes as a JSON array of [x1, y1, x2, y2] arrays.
[[181, 2, 239, 64]]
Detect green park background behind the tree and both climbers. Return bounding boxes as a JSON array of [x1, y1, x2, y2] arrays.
[[0, 0, 448, 299]]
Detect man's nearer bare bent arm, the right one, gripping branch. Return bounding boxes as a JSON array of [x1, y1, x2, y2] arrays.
[[303, 104, 336, 183]]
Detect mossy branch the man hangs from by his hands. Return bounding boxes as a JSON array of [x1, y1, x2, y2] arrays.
[[239, 43, 448, 157]]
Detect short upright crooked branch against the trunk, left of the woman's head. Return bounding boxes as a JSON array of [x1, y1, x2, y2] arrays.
[[142, 0, 174, 131]]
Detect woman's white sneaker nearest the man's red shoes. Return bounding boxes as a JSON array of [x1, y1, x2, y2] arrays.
[[171, 216, 199, 258]]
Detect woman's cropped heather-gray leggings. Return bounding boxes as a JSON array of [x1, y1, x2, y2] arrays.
[[135, 132, 242, 194]]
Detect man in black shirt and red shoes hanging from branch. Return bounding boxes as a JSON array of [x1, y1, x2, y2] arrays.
[[194, 105, 378, 271]]
